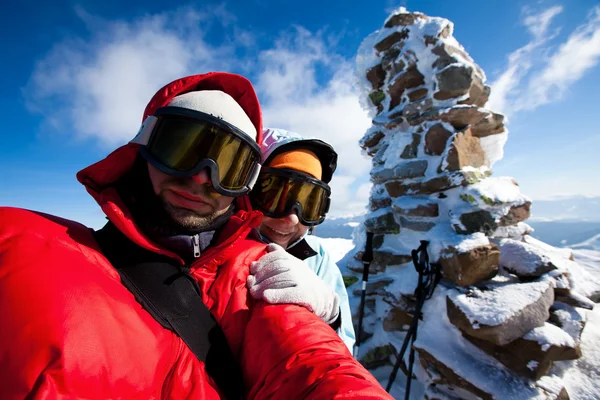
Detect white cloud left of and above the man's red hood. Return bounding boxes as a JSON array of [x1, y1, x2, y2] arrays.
[[24, 5, 233, 147]]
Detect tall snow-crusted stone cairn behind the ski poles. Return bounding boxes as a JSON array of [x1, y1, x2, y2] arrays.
[[342, 8, 600, 400]]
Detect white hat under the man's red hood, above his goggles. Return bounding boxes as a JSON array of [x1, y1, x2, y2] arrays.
[[132, 90, 257, 145]]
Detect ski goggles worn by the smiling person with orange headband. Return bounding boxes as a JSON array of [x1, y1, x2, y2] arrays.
[[250, 167, 331, 226]]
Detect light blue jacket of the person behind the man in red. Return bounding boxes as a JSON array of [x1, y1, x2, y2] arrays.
[[254, 230, 356, 354]]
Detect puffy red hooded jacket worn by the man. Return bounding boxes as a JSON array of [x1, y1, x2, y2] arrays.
[[0, 73, 391, 400]]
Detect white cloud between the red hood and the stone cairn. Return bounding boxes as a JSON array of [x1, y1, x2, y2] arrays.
[[257, 28, 371, 216]]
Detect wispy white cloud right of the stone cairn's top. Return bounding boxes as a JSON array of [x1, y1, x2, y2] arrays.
[[488, 6, 600, 116]]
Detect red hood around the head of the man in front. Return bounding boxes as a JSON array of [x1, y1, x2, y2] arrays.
[[77, 72, 262, 260]]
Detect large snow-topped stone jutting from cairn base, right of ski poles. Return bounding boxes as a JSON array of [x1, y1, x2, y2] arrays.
[[446, 281, 554, 346]]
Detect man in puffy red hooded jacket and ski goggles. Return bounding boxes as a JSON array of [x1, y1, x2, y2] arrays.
[[0, 73, 390, 399]]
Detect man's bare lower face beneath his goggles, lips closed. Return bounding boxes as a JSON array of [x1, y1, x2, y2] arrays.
[[148, 163, 233, 229]]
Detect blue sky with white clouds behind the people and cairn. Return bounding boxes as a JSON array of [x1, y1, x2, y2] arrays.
[[0, 0, 600, 227]]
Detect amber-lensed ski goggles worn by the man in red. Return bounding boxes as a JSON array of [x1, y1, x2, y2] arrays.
[[134, 107, 261, 197]]
